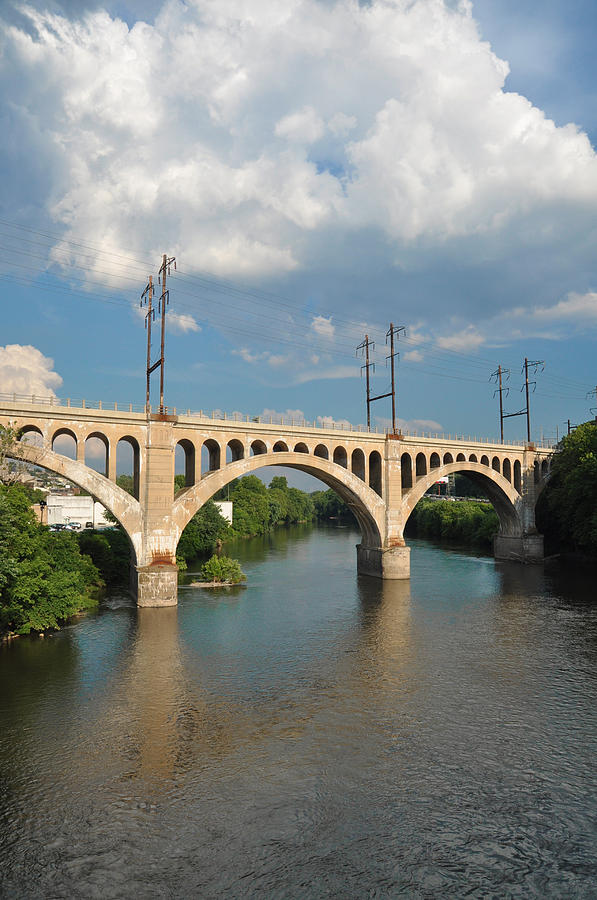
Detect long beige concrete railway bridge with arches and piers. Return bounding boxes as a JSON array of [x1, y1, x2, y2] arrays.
[[0, 397, 551, 606]]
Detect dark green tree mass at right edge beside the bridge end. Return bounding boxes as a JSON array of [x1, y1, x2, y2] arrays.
[[536, 422, 597, 556]]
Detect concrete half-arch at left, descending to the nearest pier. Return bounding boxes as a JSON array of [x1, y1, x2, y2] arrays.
[[10, 442, 143, 559]]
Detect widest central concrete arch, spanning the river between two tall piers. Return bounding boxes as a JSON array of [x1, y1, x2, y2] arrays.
[[173, 451, 385, 547]]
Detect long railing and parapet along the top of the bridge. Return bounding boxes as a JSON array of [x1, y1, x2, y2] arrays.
[[0, 393, 556, 449]]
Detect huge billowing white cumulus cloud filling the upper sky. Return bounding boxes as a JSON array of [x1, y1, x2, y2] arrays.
[[0, 0, 597, 336]]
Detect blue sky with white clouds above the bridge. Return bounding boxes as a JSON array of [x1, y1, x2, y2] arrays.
[[0, 0, 597, 458]]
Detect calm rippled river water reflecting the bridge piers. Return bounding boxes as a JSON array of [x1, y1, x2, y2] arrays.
[[0, 527, 597, 898]]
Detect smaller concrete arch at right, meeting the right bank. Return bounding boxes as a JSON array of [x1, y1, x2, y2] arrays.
[[402, 461, 523, 537]]
